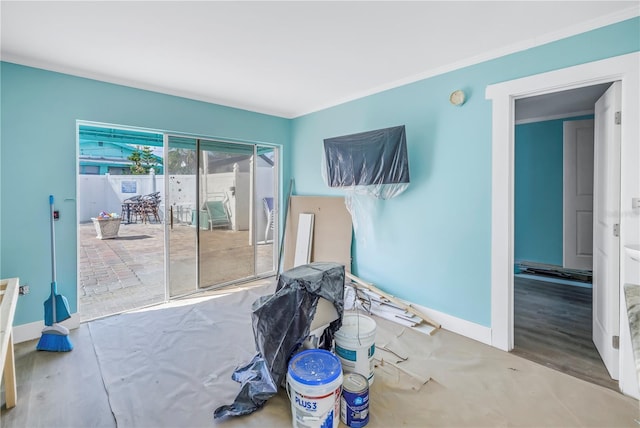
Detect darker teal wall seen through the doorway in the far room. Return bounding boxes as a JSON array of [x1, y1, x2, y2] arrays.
[[514, 115, 593, 266]]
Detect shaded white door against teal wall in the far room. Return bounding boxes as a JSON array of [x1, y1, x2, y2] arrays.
[[562, 119, 593, 270]]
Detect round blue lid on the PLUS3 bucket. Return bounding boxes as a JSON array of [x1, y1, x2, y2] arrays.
[[289, 349, 342, 385]]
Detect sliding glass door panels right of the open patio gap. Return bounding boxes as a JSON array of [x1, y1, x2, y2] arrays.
[[165, 135, 277, 297]]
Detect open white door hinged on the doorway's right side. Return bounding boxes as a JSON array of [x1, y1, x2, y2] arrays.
[[593, 82, 634, 379]]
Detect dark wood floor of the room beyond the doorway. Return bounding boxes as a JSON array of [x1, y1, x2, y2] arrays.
[[512, 276, 619, 391]]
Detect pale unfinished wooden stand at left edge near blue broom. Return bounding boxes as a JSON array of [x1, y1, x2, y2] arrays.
[[0, 278, 19, 409]]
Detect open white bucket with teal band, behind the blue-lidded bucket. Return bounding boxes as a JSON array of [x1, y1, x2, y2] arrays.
[[335, 314, 376, 385]]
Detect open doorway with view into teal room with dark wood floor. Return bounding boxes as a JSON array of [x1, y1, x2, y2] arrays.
[[513, 83, 618, 390]]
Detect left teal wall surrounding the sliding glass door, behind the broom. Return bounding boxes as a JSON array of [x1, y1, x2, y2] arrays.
[[0, 62, 291, 325]]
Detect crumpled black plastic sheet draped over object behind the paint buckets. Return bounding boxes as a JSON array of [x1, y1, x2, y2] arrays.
[[213, 262, 344, 419]]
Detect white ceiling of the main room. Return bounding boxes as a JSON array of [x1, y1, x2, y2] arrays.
[[0, 0, 640, 118]]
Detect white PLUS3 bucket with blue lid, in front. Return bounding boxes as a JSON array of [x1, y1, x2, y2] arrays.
[[287, 349, 342, 428]]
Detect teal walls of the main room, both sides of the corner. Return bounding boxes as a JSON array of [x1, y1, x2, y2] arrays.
[[0, 18, 640, 326]]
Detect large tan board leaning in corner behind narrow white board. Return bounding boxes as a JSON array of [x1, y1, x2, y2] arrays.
[[283, 196, 353, 272]]
